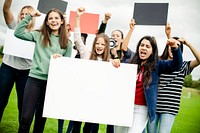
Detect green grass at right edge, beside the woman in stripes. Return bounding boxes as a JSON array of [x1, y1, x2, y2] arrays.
[[172, 89, 200, 133]]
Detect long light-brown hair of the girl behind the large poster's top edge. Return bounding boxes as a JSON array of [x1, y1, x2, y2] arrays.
[[90, 33, 110, 61]]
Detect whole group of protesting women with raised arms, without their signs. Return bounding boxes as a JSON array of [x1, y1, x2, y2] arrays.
[[0, 0, 200, 133]]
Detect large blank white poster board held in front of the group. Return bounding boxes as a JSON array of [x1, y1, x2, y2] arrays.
[[43, 57, 137, 126]]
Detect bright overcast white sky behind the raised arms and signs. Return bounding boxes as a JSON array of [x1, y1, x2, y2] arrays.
[[0, 0, 200, 80]]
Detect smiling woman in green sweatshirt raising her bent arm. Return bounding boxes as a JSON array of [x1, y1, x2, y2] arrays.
[[14, 9, 72, 133]]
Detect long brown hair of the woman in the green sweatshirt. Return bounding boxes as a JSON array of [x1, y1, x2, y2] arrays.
[[39, 8, 69, 49]]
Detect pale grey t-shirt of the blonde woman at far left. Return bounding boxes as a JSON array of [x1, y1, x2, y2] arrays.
[[3, 20, 32, 70]]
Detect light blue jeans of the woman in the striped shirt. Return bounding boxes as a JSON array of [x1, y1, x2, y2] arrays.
[[147, 113, 175, 133]]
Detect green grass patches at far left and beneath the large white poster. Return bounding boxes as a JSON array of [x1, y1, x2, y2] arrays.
[[0, 89, 106, 133]]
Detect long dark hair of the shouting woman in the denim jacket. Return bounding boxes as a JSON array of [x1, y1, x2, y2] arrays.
[[131, 36, 158, 88]]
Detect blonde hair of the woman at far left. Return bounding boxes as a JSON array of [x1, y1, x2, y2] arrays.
[[17, 5, 35, 31]]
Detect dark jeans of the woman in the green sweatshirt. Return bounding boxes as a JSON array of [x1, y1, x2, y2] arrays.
[[18, 77, 47, 133]]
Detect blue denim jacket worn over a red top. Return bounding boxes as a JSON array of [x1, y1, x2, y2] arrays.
[[144, 48, 183, 122]]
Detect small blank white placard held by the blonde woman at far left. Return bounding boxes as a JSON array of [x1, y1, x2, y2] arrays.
[[3, 29, 35, 60]]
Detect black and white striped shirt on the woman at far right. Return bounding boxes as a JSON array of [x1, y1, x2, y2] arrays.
[[156, 61, 192, 115]]
